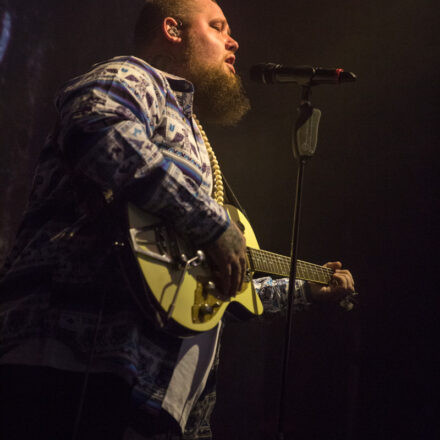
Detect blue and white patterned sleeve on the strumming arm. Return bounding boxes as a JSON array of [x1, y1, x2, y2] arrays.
[[57, 58, 229, 245]]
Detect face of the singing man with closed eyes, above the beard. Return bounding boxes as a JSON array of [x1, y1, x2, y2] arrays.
[[183, 0, 238, 75]]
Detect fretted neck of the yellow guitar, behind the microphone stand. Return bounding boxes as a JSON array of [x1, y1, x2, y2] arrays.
[[247, 248, 333, 284]]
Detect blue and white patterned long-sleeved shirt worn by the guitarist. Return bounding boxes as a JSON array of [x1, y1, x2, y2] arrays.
[[0, 57, 307, 439]]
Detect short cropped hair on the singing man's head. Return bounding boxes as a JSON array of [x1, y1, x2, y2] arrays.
[[134, 0, 217, 50]]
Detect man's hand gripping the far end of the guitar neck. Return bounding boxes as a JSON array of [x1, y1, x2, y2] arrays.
[[309, 261, 355, 303]]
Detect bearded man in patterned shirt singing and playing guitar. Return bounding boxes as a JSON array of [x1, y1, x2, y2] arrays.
[[0, 0, 354, 439]]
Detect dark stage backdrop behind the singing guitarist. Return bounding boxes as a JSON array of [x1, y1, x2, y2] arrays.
[[0, 0, 440, 440]]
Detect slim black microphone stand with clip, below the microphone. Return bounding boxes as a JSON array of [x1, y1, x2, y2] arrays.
[[278, 84, 321, 440]]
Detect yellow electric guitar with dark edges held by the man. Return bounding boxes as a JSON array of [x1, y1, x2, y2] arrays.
[[127, 204, 333, 336]]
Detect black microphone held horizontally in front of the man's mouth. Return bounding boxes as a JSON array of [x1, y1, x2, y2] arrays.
[[249, 63, 357, 86]]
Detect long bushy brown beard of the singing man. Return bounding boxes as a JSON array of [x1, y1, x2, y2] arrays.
[[185, 41, 251, 126]]
